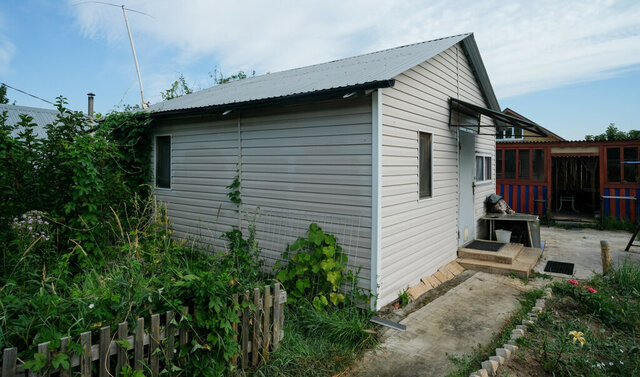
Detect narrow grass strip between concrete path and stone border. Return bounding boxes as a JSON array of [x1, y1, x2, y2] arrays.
[[447, 289, 544, 377]]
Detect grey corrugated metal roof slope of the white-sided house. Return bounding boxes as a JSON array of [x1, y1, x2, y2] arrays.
[[149, 33, 472, 112]]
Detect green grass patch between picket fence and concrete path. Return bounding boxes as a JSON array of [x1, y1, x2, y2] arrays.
[[254, 302, 376, 377]]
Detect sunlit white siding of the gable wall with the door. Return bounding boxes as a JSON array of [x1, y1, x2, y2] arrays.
[[378, 42, 495, 305]]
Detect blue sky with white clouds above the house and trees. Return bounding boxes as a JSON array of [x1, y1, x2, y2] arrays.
[[0, 0, 640, 140]]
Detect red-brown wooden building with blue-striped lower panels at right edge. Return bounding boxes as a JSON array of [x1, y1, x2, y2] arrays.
[[496, 114, 640, 221]]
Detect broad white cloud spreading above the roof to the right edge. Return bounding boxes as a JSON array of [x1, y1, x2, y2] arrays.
[[67, 0, 640, 98]]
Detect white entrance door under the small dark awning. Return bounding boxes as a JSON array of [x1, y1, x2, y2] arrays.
[[458, 128, 476, 246]]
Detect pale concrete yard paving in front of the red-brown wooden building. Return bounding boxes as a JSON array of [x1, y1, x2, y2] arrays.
[[534, 226, 640, 280]]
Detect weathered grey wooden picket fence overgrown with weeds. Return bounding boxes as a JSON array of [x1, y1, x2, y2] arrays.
[[1, 284, 287, 377]]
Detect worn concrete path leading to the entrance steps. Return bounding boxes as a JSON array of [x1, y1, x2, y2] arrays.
[[341, 271, 536, 377]]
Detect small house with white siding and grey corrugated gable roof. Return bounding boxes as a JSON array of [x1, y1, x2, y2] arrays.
[[150, 34, 531, 307]]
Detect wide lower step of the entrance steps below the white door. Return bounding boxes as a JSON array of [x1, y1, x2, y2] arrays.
[[456, 247, 542, 278]]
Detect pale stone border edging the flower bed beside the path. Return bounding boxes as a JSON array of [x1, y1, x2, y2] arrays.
[[469, 288, 551, 377]]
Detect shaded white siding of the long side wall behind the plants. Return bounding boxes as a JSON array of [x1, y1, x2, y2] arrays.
[[155, 97, 372, 288]]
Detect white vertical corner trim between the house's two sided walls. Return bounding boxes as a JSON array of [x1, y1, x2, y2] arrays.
[[371, 89, 382, 310]]
